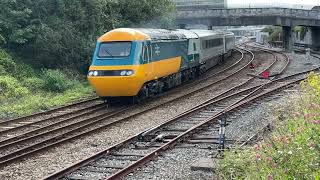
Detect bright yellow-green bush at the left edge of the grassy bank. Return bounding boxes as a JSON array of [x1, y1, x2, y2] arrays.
[[0, 76, 29, 98]]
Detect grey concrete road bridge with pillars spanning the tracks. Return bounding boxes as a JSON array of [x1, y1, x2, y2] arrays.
[[176, 6, 320, 50]]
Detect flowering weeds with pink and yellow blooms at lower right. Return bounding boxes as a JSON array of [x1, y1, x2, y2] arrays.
[[219, 73, 320, 179]]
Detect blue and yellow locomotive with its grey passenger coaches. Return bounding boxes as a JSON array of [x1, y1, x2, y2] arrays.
[[88, 28, 235, 103]]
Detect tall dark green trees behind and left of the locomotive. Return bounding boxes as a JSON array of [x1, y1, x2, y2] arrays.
[[0, 0, 174, 72]]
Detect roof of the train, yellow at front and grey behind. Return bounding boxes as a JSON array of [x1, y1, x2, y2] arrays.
[[98, 28, 234, 42]]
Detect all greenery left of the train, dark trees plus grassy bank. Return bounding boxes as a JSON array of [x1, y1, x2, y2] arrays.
[[0, 0, 174, 118]]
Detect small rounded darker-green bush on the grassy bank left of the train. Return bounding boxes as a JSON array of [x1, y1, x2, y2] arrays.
[[43, 69, 75, 92]]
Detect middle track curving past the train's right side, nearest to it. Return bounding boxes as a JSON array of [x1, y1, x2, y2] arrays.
[[0, 48, 254, 166]]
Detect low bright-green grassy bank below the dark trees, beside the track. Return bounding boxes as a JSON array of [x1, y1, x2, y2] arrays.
[[0, 50, 93, 118]]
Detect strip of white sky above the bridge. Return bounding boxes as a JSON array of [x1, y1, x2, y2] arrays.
[[227, 0, 320, 8]]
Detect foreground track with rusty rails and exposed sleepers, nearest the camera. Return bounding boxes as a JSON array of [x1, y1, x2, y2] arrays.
[[46, 64, 318, 179]]
